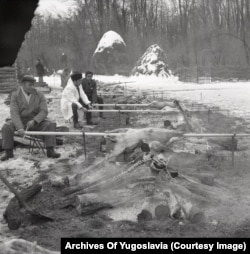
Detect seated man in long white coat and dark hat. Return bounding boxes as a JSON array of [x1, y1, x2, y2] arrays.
[[61, 72, 92, 129]]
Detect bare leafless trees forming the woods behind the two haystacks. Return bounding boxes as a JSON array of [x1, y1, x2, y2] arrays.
[[18, 0, 250, 74]]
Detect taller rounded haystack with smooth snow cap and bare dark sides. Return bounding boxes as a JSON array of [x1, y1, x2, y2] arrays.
[[92, 31, 127, 75]]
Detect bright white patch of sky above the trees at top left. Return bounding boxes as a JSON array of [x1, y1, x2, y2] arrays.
[[35, 0, 77, 17]]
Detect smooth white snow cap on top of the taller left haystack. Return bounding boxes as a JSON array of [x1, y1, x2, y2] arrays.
[[94, 31, 126, 54]]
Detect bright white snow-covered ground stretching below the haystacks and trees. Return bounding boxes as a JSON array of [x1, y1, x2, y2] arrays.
[[44, 75, 250, 123]]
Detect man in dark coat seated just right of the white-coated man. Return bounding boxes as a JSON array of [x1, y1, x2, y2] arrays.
[[82, 71, 105, 125]]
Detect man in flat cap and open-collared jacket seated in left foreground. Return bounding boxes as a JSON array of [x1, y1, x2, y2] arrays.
[[1, 75, 60, 161]]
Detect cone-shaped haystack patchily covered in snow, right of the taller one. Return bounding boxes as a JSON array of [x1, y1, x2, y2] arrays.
[[131, 44, 171, 77]]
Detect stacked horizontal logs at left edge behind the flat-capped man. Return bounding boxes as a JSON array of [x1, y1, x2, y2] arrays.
[[0, 67, 17, 93]]
